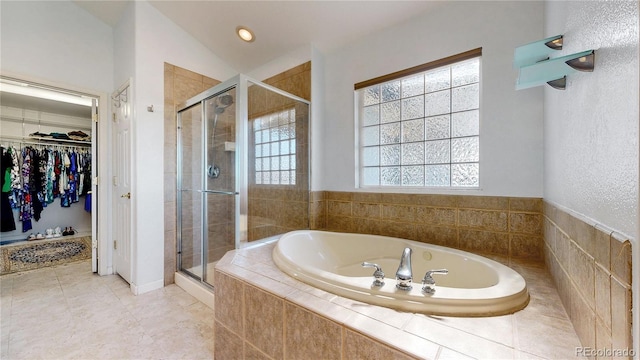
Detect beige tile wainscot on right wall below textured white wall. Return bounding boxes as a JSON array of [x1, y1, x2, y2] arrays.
[[544, 202, 637, 353]]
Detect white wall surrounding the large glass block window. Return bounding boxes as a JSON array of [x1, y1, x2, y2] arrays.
[[317, 1, 543, 197]]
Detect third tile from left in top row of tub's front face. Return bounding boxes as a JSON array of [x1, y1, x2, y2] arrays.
[[284, 303, 342, 360]]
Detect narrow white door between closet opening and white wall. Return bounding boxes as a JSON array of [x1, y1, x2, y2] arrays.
[[112, 83, 132, 283]]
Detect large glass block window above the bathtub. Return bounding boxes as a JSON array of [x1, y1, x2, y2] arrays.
[[356, 56, 480, 187]]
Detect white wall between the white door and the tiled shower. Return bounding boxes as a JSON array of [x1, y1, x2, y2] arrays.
[[121, 1, 236, 293]]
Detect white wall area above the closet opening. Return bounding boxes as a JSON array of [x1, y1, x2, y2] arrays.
[[0, 1, 113, 92]]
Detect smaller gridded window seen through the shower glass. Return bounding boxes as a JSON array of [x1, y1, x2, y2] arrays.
[[253, 109, 296, 185]]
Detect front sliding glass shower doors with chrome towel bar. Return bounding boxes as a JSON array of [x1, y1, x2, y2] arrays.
[[177, 88, 238, 286]]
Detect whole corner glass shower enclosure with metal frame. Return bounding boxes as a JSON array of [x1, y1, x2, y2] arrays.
[[177, 75, 310, 286]]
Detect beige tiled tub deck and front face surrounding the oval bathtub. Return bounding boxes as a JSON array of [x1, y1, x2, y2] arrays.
[[214, 243, 581, 359]]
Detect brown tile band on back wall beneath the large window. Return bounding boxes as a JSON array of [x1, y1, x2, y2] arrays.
[[311, 191, 544, 261]]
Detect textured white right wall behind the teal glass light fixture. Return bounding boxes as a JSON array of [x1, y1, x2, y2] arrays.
[[544, 1, 640, 357]]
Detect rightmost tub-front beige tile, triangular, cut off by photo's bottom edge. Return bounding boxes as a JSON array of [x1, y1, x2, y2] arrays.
[[342, 330, 413, 360]]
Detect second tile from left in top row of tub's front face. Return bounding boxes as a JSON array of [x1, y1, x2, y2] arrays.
[[245, 285, 284, 359]]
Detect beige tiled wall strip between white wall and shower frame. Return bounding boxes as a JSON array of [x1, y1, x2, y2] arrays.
[[164, 63, 220, 286]]
